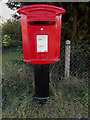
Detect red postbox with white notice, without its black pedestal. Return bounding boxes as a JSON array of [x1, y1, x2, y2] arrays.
[[18, 5, 66, 64]]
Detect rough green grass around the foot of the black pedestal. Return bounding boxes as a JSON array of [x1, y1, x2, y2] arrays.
[[2, 48, 88, 118]]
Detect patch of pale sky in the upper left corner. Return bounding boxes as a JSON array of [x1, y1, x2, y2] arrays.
[[0, 0, 16, 24]]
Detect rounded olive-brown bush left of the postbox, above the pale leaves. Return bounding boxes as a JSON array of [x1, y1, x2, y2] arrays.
[[2, 19, 21, 41]]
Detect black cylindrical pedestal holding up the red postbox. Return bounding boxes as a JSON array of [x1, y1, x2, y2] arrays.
[[35, 65, 49, 100]]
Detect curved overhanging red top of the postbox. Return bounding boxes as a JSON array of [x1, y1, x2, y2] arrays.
[[17, 4, 66, 15]]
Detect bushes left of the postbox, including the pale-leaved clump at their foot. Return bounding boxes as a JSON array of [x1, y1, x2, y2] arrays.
[[2, 19, 22, 48]]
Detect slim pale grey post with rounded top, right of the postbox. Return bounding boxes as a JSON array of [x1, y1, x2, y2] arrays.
[[65, 40, 70, 79]]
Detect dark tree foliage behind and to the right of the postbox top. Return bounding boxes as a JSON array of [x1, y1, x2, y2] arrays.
[[7, 2, 90, 49]]
